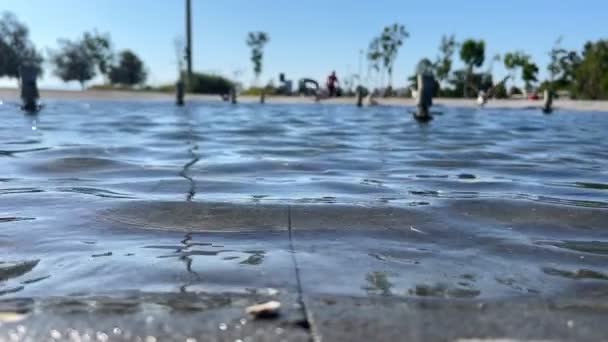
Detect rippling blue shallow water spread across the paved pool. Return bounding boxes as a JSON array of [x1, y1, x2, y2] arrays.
[[0, 101, 608, 298]]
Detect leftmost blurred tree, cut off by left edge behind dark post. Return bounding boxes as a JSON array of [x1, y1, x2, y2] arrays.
[[0, 12, 43, 78]]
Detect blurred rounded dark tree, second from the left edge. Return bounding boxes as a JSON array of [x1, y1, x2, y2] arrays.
[[50, 39, 95, 90]]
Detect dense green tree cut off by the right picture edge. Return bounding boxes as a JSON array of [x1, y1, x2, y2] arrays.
[[574, 40, 608, 100]]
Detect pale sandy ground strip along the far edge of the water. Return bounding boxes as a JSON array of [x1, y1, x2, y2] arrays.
[[0, 88, 608, 112]]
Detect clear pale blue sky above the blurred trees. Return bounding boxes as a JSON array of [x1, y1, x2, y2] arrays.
[[0, 0, 608, 88]]
